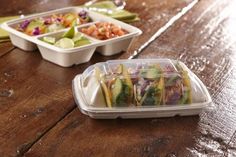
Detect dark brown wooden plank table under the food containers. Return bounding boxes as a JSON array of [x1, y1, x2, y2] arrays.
[[0, 0, 236, 157]]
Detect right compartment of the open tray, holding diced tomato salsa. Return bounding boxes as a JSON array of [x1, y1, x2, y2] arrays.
[[80, 20, 142, 56]]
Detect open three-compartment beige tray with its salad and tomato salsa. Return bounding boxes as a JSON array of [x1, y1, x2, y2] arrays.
[[1, 7, 142, 67]]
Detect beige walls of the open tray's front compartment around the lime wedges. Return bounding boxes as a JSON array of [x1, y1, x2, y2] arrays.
[[36, 29, 98, 67]]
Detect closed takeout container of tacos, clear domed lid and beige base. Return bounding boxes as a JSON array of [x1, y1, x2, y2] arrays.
[[72, 59, 211, 119]]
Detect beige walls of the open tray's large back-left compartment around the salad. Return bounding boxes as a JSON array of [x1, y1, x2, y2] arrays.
[[1, 7, 96, 51]]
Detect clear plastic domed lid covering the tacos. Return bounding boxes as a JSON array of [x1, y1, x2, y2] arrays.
[[79, 59, 210, 108]]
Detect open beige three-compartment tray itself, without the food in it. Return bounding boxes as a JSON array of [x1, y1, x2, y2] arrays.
[[1, 7, 142, 67]]
